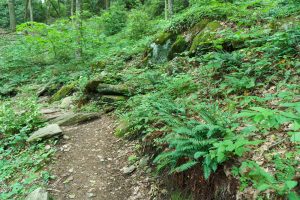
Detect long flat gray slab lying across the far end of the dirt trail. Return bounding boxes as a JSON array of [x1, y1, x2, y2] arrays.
[[51, 113, 100, 126]]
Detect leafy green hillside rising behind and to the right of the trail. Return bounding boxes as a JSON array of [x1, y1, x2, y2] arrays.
[[0, 0, 300, 200]]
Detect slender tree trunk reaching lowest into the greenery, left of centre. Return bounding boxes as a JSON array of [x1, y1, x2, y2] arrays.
[[76, 0, 82, 60]]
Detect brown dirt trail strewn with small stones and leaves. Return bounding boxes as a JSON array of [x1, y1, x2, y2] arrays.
[[48, 116, 151, 200]]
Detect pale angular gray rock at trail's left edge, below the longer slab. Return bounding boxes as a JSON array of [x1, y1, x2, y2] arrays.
[[27, 124, 62, 142]]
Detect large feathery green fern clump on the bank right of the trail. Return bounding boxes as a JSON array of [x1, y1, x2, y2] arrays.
[[154, 103, 259, 179]]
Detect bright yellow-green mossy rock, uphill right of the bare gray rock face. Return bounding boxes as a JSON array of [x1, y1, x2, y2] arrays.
[[190, 21, 221, 52]]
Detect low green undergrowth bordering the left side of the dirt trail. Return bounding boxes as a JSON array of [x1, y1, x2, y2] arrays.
[[0, 98, 54, 199]]
